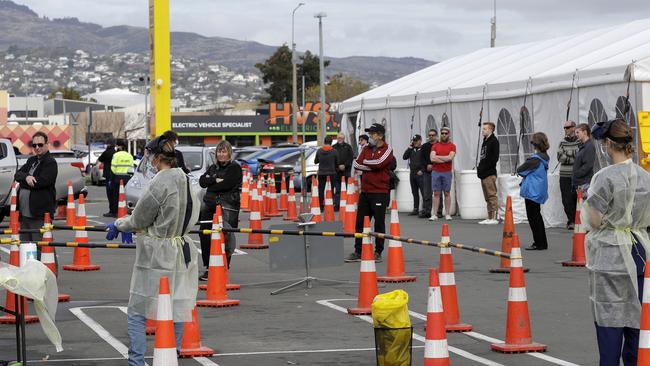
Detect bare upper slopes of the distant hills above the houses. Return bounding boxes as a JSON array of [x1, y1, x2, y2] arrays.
[[0, 0, 434, 84]]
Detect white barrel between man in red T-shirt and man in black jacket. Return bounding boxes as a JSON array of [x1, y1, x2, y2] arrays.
[[457, 170, 487, 220]]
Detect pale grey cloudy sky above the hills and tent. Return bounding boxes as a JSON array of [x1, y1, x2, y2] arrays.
[[15, 0, 650, 61]]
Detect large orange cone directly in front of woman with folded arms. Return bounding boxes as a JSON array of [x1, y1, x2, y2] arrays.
[[196, 213, 239, 308]]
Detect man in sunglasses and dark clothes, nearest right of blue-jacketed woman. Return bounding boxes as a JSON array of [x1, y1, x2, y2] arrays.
[[557, 121, 580, 230]]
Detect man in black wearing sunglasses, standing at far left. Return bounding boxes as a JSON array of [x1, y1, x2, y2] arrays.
[[14, 131, 59, 261]]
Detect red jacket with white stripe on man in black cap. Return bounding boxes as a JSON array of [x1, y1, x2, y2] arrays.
[[352, 143, 393, 193]]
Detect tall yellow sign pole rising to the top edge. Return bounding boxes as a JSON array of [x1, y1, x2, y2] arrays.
[[149, 0, 171, 136]]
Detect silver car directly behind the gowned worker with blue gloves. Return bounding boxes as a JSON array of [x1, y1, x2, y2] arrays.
[[124, 146, 216, 212]]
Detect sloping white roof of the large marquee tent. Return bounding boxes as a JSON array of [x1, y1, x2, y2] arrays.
[[340, 19, 650, 113]]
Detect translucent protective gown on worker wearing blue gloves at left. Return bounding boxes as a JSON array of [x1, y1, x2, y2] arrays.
[[115, 168, 201, 322]]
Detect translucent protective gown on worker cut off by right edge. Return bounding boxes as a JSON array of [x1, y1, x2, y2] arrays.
[[580, 159, 650, 329]]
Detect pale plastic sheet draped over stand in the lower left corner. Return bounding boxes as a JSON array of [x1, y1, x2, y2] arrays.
[[0, 259, 63, 352]]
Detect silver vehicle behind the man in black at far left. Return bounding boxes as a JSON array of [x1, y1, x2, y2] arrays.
[[0, 139, 88, 221]]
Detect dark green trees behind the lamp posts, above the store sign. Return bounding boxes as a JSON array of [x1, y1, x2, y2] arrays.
[[255, 44, 330, 103]]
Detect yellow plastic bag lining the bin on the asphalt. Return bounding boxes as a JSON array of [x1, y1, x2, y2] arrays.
[[372, 290, 411, 329]]
